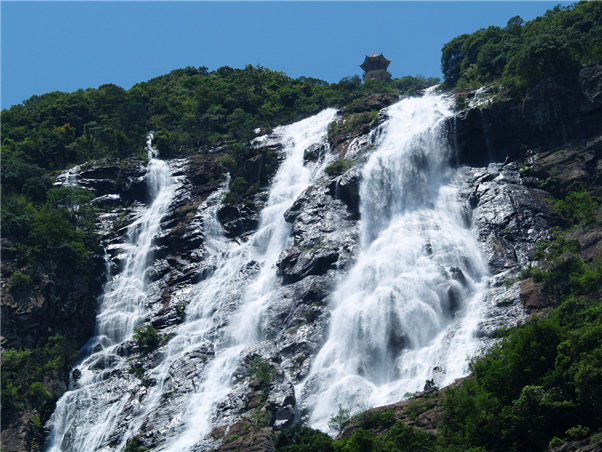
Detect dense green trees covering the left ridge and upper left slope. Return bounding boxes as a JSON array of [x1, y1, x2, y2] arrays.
[[2, 65, 420, 268]]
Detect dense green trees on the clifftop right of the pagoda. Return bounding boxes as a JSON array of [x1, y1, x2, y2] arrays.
[[441, 1, 602, 92]]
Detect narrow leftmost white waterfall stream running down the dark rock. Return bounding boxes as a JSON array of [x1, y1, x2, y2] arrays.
[[48, 135, 175, 452]]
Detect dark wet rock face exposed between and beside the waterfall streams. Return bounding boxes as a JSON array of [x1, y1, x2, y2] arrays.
[[2, 67, 602, 451]]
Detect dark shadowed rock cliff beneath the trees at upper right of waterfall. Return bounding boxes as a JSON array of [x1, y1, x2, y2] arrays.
[[447, 66, 602, 165]]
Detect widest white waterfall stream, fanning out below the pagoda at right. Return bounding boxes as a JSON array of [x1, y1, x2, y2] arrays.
[[297, 95, 488, 431]]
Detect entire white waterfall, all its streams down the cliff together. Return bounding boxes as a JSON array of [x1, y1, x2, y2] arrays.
[[44, 94, 500, 446]]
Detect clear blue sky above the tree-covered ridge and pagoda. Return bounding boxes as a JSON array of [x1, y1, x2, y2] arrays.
[[0, 0, 572, 108]]
